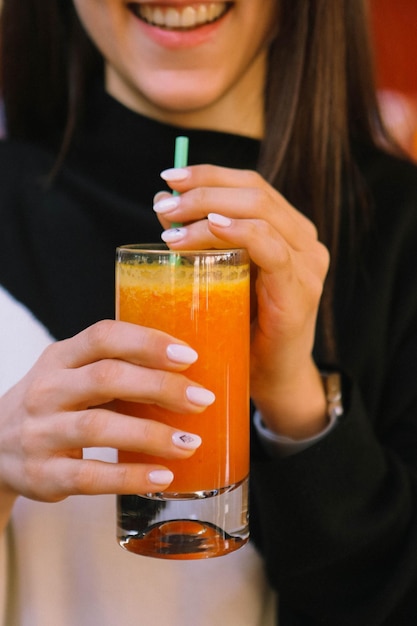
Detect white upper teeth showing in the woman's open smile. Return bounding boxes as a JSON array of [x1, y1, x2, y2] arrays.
[[129, 2, 232, 30]]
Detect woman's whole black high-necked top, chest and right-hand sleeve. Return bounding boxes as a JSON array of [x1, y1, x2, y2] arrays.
[[0, 85, 417, 626]]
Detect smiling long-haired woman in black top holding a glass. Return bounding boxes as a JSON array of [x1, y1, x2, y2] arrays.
[[0, 0, 417, 626]]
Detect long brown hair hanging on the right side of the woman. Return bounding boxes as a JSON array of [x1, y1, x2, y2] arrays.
[[259, 0, 390, 365]]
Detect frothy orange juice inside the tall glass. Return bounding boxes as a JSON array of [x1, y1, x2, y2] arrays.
[[116, 251, 249, 494]]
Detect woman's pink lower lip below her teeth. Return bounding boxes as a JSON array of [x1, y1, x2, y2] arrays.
[[129, 11, 230, 49]]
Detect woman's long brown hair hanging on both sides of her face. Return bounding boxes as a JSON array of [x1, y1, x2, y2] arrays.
[[0, 0, 390, 361]]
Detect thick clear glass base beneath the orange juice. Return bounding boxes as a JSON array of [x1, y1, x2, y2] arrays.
[[117, 478, 249, 559]]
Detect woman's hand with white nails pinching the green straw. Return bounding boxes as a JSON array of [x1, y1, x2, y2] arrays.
[[154, 165, 329, 438]]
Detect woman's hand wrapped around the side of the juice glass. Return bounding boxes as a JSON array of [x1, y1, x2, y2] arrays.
[[0, 320, 214, 502]]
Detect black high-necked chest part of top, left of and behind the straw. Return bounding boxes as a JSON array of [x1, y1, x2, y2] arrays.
[[0, 86, 258, 339]]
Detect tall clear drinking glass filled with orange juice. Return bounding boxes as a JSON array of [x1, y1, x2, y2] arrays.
[[116, 244, 250, 559]]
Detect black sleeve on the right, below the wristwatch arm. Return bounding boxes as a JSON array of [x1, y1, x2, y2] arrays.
[[251, 152, 417, 626]]
